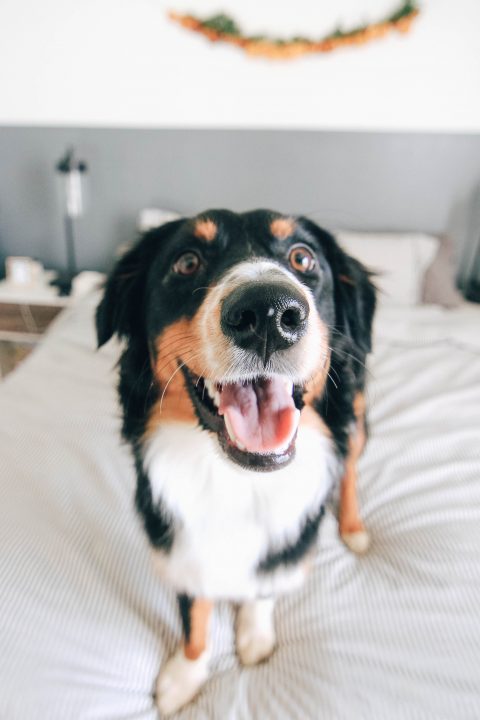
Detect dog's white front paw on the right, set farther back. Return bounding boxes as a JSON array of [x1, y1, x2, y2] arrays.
[[237, 600, 276, 665]]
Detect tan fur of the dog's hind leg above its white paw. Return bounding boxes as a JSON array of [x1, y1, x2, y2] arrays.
[[339, 393, 366, 535]]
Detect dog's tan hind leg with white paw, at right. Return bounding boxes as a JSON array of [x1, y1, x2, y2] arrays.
[[339, 392, 370, 554]]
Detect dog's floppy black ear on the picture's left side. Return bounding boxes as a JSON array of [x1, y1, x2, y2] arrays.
[[96, 220, 183, 347]]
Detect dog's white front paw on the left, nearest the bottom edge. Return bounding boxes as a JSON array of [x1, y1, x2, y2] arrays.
[[157, 647, 209, 716]]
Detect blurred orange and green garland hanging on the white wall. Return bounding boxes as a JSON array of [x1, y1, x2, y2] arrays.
[[169, 0, 420, 60]]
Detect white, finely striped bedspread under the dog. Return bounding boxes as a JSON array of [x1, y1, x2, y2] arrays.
[[0, 299, 480, 720]]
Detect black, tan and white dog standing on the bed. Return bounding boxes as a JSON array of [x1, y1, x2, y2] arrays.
[[97, 210, 375, 714]]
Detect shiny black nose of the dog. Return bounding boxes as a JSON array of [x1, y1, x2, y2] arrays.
[[221, 282, 309, 364]]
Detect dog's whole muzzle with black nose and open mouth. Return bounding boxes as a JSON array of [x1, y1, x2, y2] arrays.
[[178, 272, 322, 471]]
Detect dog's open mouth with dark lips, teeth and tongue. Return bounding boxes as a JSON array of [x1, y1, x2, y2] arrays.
[[182, 365, 303, 470]]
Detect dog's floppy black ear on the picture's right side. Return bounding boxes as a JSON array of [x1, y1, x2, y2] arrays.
[[302, 218, 376, 354]]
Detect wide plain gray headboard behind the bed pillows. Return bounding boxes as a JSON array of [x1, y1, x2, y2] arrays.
[[0, 127, 480, 276]]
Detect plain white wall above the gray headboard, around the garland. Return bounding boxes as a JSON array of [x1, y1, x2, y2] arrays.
[[0, 0, 480, 132]]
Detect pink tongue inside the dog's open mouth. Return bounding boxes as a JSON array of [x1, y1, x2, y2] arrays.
[[218, 377, 300, 453]]
